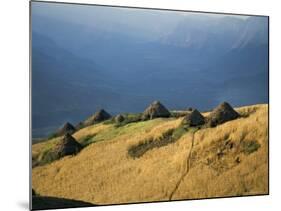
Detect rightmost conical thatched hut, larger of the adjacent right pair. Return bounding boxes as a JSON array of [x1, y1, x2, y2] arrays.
[[208, 102, 239, 127]]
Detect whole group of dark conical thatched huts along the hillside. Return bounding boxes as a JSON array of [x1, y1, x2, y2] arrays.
[[49, 101, 239, 157]]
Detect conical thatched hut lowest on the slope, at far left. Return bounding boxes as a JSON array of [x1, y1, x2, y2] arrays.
[[56, 133, 82, 157]]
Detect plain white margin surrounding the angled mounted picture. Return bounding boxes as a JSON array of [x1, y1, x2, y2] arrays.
[[0, 0, 281, 211]]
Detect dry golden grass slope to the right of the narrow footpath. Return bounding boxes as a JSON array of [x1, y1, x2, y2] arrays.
[[174, 105, 268, 199]]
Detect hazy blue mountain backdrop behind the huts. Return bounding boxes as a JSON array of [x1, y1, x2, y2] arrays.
[[32, 10, 268, 138]]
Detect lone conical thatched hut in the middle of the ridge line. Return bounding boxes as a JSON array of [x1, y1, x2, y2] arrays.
[[142, 101, 171, 120]]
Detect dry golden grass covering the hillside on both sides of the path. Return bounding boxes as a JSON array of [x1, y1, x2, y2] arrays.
[[32, 105, 268, 204]]
